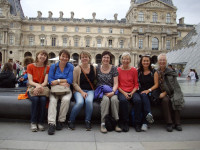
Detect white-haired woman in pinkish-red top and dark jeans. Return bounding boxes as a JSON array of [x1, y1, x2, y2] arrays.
[[117, 52, 142, 132]]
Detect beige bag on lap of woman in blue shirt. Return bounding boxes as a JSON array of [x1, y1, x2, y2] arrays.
[[51, 85, 71, 95]]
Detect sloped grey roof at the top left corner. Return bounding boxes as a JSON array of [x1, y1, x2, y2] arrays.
[[8, 0, 25, 18]]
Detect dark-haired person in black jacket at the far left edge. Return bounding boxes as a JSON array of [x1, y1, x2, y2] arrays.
[[0, 63, 16, 88]]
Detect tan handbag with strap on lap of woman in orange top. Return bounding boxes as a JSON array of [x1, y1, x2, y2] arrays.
[[28, 66, 49, 97]]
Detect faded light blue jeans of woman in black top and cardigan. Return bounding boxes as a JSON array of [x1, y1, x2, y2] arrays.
[[69, 90, 94, 122]]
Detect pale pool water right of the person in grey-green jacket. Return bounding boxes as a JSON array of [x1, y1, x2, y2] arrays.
[[178, 78, 200, 95]]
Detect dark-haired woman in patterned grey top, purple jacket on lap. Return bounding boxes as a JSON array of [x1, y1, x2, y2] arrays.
[[95, 51, 121, 133]]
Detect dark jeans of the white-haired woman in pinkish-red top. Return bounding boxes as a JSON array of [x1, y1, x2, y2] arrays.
[[118, 92, 142, 125]]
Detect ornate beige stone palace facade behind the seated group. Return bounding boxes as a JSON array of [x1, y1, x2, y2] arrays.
[[0, 0, 193, 66]]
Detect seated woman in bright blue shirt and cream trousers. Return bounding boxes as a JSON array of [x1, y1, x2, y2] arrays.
[[48, 50, 74, 135]]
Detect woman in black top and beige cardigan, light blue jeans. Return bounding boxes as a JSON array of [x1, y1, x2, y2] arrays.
[[68, 51, 96, 131]]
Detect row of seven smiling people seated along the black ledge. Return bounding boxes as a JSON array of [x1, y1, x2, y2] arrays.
[[22, 50, 184, 135]]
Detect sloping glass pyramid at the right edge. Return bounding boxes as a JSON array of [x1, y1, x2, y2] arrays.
[[167, 23, 200, 75]]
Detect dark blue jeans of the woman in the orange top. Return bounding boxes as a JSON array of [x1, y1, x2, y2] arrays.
[[28, 92, 47, 124]]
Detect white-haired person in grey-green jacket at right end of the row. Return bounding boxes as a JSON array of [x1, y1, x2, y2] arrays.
[[157, 54, 184, 132]]
